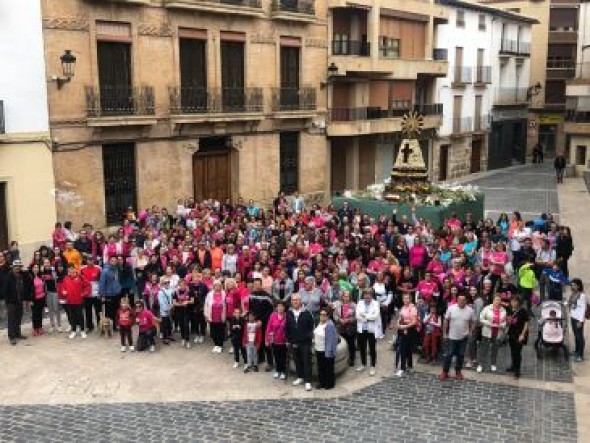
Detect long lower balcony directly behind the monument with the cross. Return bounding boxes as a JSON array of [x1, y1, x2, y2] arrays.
[[327, 100, 442, 137]]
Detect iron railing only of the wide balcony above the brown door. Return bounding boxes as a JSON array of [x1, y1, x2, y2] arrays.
[[168, 87, 264, 115]]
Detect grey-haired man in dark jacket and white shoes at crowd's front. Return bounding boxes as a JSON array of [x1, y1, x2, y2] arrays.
[[285, 294, 314, 391]]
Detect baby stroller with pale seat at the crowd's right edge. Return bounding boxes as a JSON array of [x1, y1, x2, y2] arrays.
[[535, 300, 569, 361]]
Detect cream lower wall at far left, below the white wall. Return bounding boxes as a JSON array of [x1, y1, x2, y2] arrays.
[[0, 134, 55, 259]]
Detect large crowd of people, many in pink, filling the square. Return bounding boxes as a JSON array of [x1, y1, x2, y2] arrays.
[[0, 193, 586, 390]]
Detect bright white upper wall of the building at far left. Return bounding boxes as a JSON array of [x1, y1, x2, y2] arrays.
[[0, 0, 49, 133]]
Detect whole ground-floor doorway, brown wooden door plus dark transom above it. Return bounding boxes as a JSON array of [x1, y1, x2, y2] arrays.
[[193, 137, 231, 201]]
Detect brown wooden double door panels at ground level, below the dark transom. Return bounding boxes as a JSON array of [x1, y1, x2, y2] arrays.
[[193, 152, 231, 201]]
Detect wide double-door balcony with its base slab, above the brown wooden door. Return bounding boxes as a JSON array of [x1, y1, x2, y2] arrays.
[[168, 87, 264, 124]]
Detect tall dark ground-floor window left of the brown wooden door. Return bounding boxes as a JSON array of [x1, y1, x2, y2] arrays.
[[102, 143, 137, 225]]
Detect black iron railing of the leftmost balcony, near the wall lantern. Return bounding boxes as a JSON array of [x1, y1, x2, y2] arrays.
[[86, 86, 155, 117]]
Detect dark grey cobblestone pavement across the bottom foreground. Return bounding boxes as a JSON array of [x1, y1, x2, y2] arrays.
[[0, 374, 576, 443]]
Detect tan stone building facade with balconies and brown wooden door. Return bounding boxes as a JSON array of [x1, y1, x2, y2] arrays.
[[43, 0, 329, 227]]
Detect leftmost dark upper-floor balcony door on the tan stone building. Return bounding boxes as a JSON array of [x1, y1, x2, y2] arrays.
[[96, 41, 134, 115]]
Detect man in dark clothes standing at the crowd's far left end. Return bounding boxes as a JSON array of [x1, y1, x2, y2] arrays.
[[4, 260, 33, 346]]
